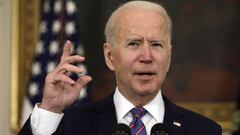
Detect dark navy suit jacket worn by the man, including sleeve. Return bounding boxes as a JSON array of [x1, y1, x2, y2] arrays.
[[19, 95, 222, 135]]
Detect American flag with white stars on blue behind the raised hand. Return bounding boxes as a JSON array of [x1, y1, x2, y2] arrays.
[[21, 0, 88, 124]]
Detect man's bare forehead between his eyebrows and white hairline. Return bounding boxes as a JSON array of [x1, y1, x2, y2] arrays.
[[116, 8, 166, 37]]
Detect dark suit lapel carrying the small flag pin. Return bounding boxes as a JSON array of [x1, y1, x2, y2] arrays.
[[163, 96, 187, 135]]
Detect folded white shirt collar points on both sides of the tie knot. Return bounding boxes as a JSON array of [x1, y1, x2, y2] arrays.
[[113, 88, 165, 123]]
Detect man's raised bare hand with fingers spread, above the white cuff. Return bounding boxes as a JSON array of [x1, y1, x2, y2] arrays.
[[40, 41, 92, 113]]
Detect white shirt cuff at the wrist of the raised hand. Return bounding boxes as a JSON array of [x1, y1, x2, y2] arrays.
[[30, 104, 64, 135]]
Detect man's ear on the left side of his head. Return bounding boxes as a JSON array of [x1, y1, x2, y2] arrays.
[[103, 43, 115, 71]]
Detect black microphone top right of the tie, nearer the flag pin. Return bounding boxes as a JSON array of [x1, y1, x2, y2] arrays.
[[151, 123, 168, 135]]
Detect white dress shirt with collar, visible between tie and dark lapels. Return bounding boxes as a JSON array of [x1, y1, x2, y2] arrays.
[[113, 88, 165, 135]]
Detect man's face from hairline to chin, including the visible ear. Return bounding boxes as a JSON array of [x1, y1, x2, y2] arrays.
[[104, 9, 171, 98]]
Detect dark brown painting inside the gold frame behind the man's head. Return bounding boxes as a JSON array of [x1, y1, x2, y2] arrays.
[[78, 0, 240, 101]]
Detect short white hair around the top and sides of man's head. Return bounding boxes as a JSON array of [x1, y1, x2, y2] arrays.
[[105, 1, 172, 44]]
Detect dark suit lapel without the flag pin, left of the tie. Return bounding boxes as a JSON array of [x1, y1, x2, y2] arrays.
[[92, 95, 117, 135]]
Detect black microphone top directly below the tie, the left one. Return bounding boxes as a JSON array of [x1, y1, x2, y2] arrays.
[[112, 123, 131, 135]]
